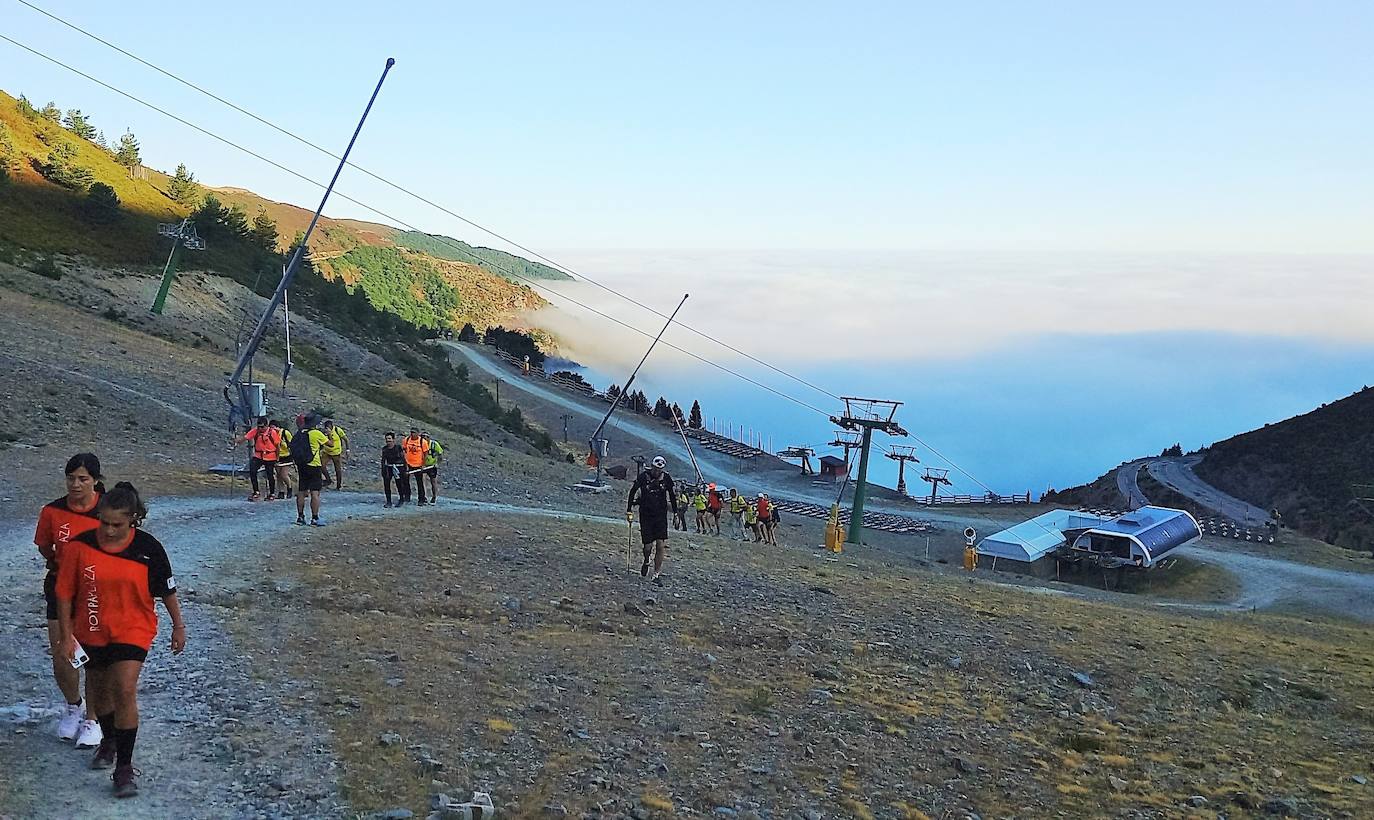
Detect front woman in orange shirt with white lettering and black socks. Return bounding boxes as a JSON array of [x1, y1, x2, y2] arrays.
[[56, 481, 185, 797]]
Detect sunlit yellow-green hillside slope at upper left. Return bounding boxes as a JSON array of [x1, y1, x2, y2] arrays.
[[0, 86, 566, 330]]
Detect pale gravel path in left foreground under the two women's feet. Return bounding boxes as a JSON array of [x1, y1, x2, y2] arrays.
[[0, 493, 618, 819]]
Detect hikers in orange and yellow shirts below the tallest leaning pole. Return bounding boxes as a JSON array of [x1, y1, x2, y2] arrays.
[[229, 413, 444, 526]]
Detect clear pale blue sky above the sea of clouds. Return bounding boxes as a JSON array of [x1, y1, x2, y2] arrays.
[[0, 0, 1374, 253]]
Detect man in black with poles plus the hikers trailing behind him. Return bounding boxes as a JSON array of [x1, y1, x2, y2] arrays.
[[625, 456, 779, 586]]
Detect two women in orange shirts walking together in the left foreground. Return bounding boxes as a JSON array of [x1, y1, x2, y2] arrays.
[[33, 453, 185, 798]]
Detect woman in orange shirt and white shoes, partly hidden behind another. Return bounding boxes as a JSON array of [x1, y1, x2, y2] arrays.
[[33, 453, 104, 749]]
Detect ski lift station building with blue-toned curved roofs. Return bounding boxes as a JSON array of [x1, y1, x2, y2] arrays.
[[978, 507, 1202, 577]]
